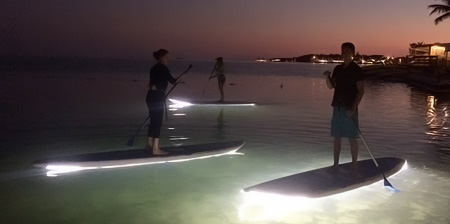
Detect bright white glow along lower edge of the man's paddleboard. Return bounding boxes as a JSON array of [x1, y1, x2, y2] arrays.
[[238, 160, 408, 221]]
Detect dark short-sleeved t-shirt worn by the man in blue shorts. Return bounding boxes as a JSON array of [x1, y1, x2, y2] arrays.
[[331, 62, 364, 108]]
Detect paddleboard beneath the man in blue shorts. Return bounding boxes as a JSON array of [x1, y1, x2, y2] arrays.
[[243, 157, 406, 198]]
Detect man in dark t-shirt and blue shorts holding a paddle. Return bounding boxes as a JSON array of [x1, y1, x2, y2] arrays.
[[323, 42, 364, 174]]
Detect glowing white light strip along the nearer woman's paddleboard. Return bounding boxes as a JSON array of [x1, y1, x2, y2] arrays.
[[45, 148, 243, 177]]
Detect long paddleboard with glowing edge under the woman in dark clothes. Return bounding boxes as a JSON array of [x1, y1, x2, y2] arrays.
[[34, 141, 245, 176]]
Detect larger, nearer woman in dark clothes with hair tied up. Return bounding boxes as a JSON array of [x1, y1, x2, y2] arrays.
[[146, 49, 185, 155]]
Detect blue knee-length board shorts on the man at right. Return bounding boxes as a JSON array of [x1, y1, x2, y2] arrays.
[[331, 107, 359, 139]]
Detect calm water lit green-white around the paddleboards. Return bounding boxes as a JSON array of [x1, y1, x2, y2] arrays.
[[0, 61, 450, 224]]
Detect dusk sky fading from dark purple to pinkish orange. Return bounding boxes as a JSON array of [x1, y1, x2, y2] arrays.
[[0, 0, 450, 60]]
